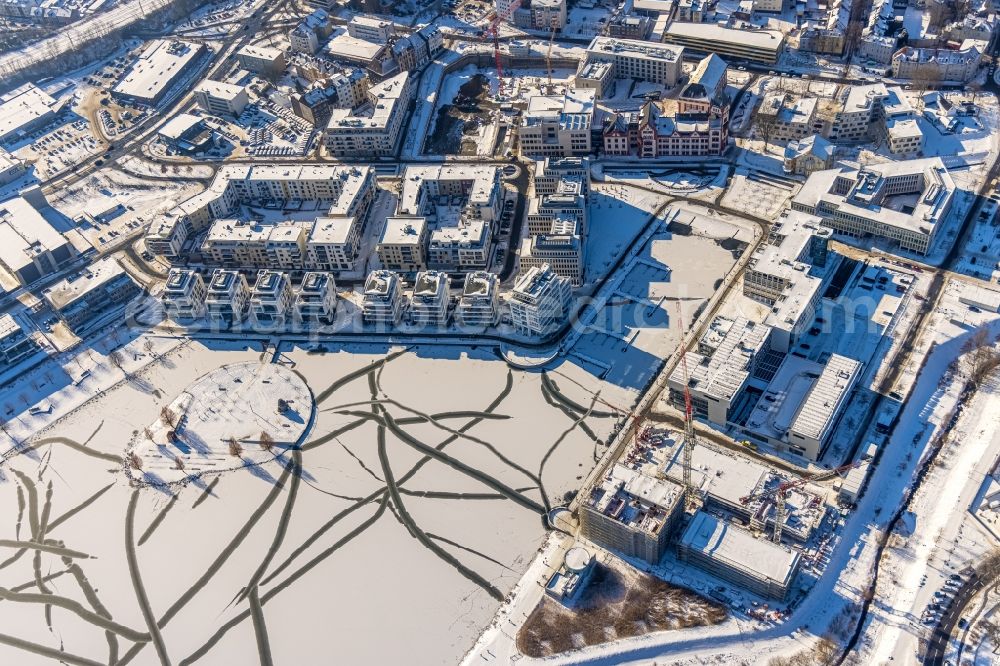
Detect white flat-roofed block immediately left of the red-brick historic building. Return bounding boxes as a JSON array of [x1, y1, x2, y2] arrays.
[[517, 88, 596, 157]]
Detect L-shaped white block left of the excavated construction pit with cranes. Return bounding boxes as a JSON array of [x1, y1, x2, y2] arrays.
[[323, 72, 413, 157]]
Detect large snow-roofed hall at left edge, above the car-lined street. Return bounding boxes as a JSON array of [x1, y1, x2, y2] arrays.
[[0, 197, 77, 286]]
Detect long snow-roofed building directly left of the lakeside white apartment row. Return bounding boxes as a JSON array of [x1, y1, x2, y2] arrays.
[[42, 257, 141, 336]]
